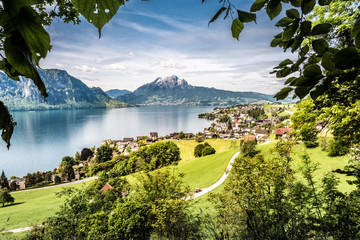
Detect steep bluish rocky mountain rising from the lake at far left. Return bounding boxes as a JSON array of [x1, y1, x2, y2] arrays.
[[0, 69, 132, 110]]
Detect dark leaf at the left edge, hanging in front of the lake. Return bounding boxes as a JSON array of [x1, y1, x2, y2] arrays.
[[0, 101, 16, 149]]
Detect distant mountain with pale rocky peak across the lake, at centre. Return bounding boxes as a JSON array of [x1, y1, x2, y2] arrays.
[[115, 76, 274, 105]]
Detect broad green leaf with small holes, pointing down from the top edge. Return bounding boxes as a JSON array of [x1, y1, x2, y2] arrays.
[[71, 0, 124, 37]]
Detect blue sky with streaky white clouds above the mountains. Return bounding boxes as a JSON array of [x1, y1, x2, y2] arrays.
[[40, 0, 293, 94]]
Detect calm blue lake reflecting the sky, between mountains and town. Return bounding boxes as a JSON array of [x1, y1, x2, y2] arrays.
[[0, 106, 213, 178]]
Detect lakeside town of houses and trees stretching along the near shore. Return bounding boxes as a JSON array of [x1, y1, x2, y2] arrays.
[[2, 104, 293, 191]]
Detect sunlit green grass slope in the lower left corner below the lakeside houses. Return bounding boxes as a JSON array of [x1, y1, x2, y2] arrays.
[[0, 182, 88, 231]]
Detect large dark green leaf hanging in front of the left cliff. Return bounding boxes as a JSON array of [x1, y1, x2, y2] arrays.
[[4, 32, 47, 97]]
